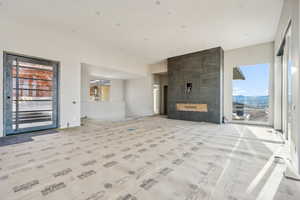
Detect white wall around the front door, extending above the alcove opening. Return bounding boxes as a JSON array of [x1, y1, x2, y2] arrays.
[[0, 19, 151, 136]]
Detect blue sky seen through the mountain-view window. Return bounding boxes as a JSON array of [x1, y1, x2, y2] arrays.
[[232, 64, 270, 96]]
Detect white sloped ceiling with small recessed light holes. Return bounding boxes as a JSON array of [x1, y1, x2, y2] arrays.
[[0, 0, 283, 63]]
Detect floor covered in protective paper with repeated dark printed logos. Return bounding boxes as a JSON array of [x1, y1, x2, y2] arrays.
[[0, 117, 300, 200]]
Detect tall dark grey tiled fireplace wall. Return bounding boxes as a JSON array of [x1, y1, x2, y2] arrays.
[[168, 48, 224, 123]]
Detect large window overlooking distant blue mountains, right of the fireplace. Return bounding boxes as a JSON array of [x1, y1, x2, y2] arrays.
[[232, 64, 270, 123]]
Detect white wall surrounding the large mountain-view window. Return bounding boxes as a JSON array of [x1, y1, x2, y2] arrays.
[[224, 42, 274, 124]]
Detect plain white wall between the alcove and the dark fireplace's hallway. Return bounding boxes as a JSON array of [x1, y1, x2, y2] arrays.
[[124, 76, 154, 117]]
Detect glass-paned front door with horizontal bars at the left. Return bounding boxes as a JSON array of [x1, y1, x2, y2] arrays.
[[3, 53, 59, 135]]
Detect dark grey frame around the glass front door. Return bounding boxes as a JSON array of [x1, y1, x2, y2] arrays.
[[2, 51, 61, 136]]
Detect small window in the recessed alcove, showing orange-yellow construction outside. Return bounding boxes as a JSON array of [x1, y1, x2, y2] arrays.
[[90, 79, 111, 101]]
